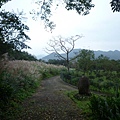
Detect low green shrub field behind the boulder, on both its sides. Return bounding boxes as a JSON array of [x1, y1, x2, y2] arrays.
[[61, 67, 120, 96]]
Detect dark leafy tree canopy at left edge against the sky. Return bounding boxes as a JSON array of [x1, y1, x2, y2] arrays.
[[0, 0, 30, 55]]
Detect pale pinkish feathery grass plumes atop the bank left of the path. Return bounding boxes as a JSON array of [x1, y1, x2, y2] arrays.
[[2, 60, 65, 80]]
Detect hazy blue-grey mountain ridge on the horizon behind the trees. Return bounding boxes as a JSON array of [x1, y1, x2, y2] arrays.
[[42, 49, 120, 61]]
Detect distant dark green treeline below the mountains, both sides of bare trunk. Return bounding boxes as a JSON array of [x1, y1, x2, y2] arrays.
[[44, 49, 120, 73]]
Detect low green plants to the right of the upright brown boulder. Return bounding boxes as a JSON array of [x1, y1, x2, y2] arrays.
[[90, 71, 120, 95]]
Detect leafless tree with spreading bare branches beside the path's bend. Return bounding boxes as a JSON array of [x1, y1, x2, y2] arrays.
[[45, 35, 82, 71]]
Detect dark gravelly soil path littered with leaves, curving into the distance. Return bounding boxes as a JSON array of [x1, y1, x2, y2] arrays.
[[18, 76, 84, 120]]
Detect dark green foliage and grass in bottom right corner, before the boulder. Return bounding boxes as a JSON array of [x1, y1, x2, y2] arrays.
[[66, 91, 120, 120]]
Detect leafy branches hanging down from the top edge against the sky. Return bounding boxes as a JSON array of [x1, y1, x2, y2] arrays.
[[31, 0, 120, 29]]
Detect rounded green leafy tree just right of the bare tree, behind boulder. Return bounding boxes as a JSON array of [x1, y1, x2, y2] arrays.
[[76, 49, 94, 74]]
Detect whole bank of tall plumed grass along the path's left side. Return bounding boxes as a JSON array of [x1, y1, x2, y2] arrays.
[[0, 60, 65, 120]]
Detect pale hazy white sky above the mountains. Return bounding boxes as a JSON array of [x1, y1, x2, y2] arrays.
[[4, 0, 120, 55]]
